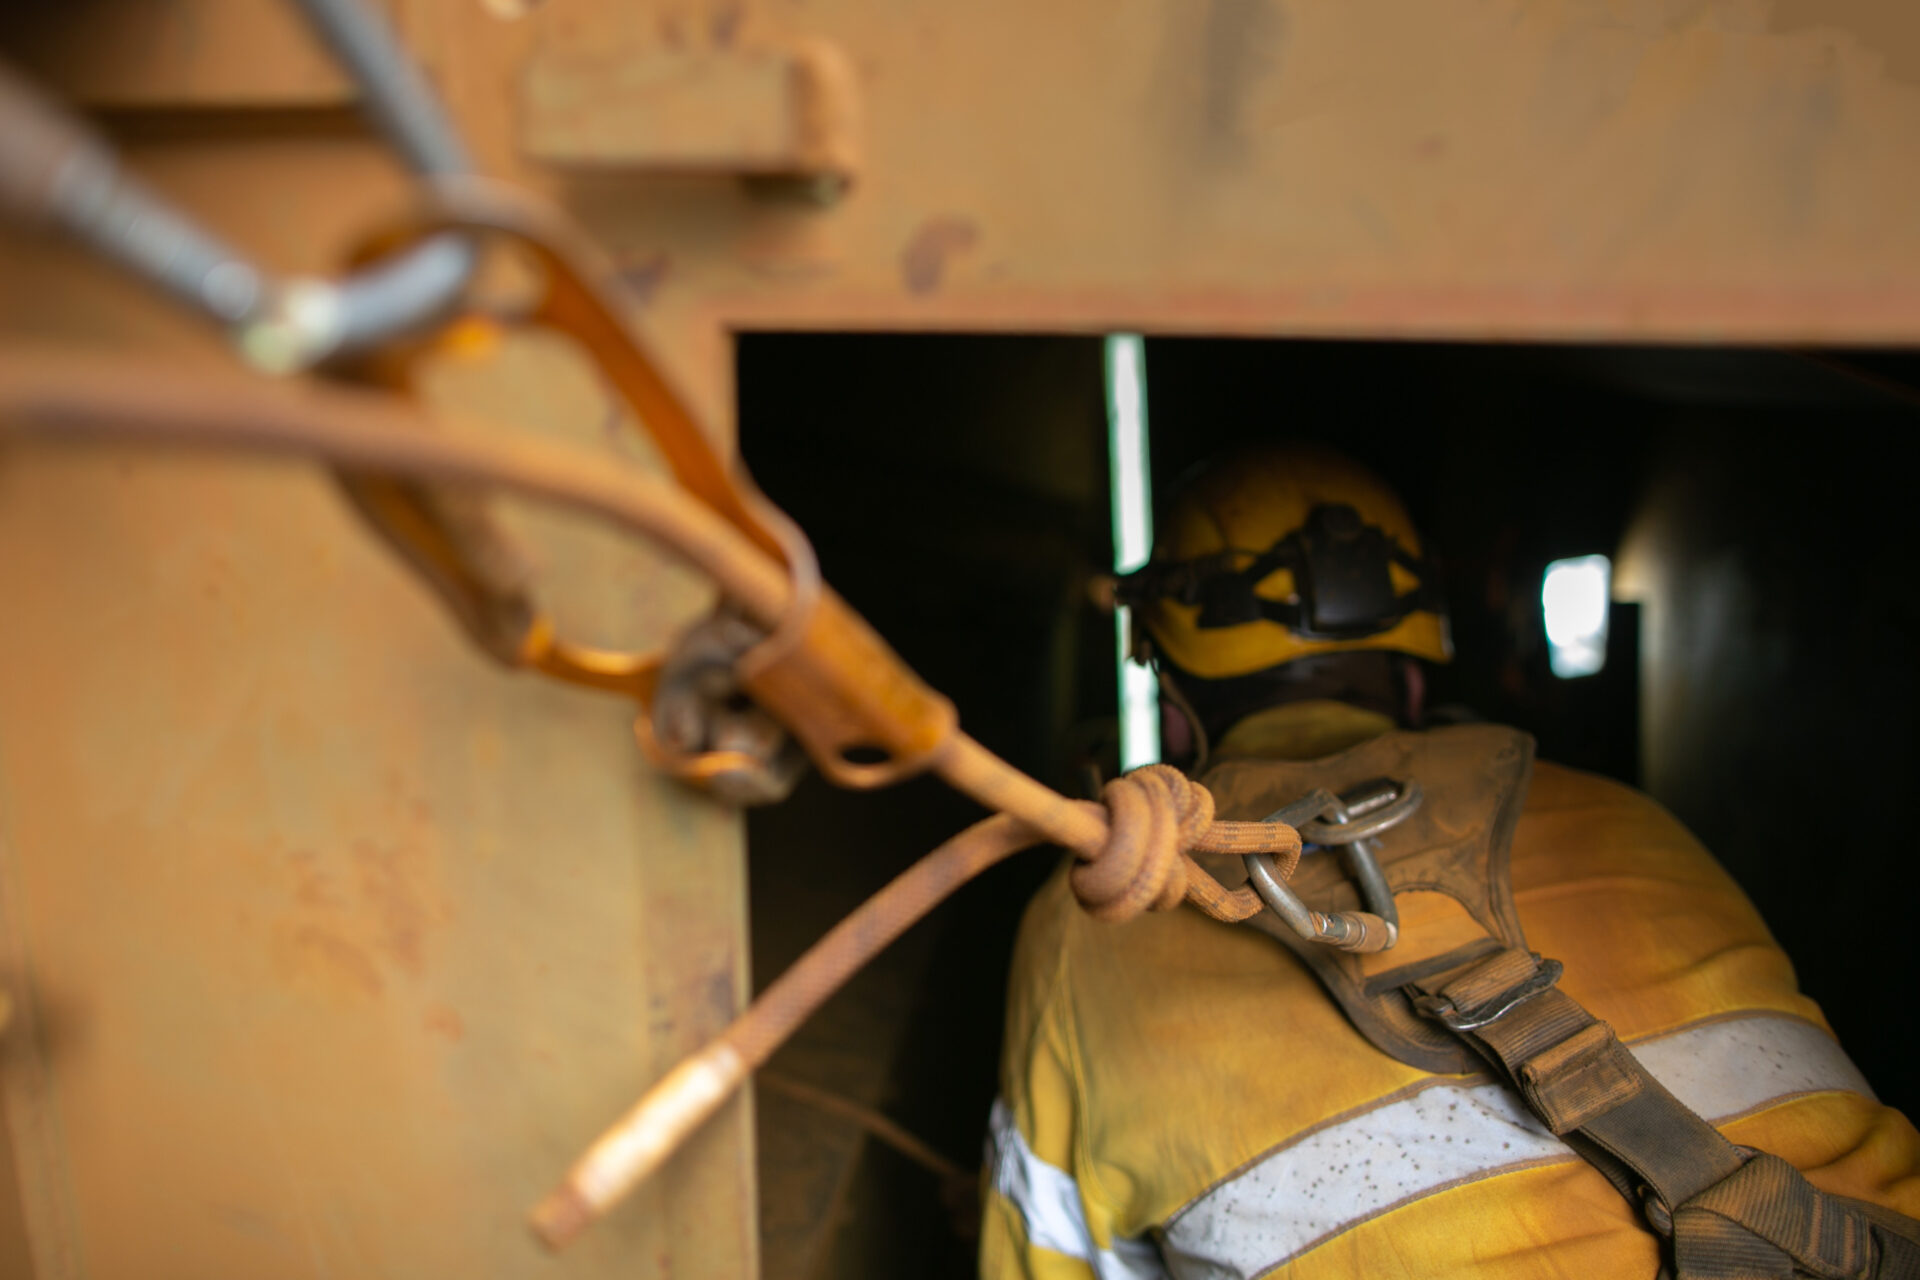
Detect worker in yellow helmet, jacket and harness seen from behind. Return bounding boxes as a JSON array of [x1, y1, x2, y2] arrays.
[[981, 445, 1920, 1280]]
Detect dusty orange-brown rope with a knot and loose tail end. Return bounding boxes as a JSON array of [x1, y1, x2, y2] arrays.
[[0, 347, 1300, 1247]]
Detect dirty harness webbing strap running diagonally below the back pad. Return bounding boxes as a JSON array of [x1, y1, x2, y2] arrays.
[[1407, 948, 1920, 1280]]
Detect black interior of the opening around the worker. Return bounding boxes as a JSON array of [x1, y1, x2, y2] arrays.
[[739, 334, 1920, 1280]]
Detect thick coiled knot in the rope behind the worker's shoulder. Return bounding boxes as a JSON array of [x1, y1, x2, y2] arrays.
[[1069, 764, 1213, 921]]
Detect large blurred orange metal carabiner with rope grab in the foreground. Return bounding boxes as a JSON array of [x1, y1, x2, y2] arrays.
[[322, 178, 956, 793]]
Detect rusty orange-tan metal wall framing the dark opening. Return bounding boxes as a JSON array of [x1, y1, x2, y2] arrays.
[[0, 0, 1920, 1280]]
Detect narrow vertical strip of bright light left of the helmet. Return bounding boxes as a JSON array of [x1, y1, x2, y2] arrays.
[[1106, 334, 1160, 770]]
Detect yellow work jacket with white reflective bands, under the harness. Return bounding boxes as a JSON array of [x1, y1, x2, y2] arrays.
[[981, 702, 1920, 1280]]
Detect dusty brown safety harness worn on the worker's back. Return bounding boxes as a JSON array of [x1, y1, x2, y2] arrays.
[[1206, 725, 1920, 1280]]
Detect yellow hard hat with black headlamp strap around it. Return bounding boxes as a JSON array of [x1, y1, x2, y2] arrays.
[[1117, 443, 1453, 679]]
